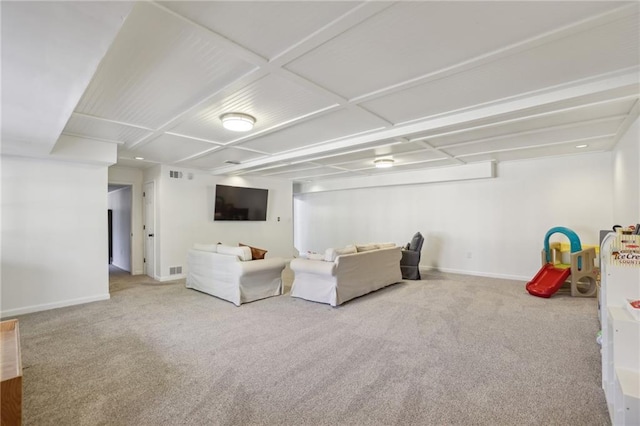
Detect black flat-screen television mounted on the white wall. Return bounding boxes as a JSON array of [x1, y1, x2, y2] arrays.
[[213, 185, 269, 220]]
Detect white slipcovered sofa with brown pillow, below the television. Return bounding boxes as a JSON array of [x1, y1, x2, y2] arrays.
[[186, 244, 286, 306]]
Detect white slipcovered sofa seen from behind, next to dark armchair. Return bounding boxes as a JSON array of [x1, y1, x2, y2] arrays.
[[290, 244, 402, 306]]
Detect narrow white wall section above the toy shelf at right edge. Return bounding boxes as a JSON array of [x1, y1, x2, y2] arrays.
[[613, 118, 640, 226]]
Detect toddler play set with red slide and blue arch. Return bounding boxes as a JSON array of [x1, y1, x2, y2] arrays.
[[525, 226, 599, 298]]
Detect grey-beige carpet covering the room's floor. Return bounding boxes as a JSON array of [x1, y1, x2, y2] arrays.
[[11, 272, 609, 425]]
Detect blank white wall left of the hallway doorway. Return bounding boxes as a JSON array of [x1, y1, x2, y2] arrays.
[[0, 156, 109, 317]]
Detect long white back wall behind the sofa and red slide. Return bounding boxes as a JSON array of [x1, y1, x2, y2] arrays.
[[294, 153, 612, 280]]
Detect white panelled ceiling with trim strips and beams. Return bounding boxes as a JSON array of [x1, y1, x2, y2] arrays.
[[2, 1, 640, 182]]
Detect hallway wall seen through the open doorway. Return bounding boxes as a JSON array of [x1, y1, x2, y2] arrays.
[[107, 186, 132, 272]]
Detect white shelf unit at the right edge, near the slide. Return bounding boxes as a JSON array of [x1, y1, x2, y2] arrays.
[[600, 233, 640, 426]]
